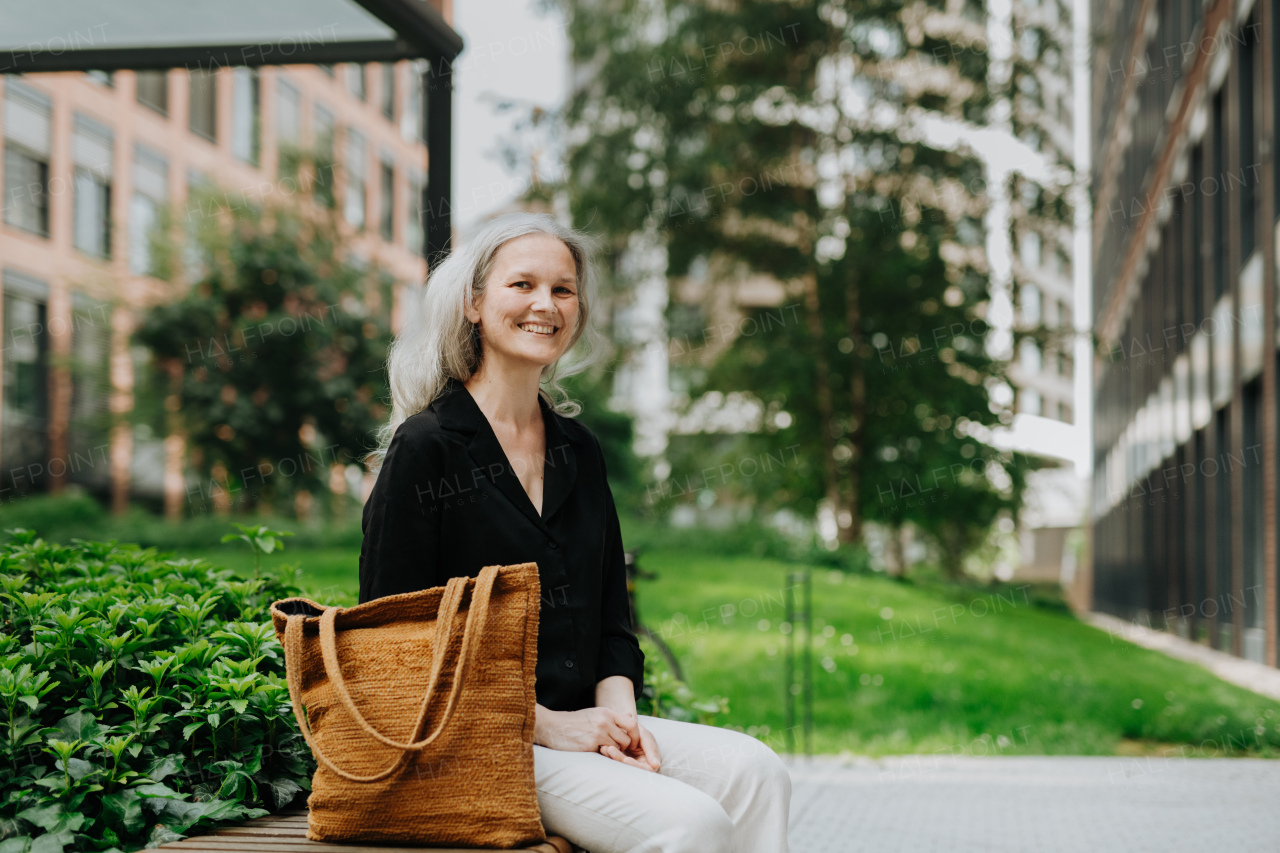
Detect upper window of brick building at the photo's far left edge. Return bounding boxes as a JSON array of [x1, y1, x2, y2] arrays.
[[4, 79, 52, 237]]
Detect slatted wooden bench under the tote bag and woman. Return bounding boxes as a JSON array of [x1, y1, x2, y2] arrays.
[[140, 808, 573, 853]]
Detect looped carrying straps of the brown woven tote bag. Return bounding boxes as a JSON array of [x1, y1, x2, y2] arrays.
[[284, 566, 498, 783]]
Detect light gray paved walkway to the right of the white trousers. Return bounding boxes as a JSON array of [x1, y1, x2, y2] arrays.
[[785, 754, 1280, 853]]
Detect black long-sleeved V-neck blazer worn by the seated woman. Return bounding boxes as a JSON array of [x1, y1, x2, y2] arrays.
[[360, 379, 644, 711]]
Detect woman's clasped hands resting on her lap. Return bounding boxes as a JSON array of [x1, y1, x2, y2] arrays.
[[534, 704, 662, 772]]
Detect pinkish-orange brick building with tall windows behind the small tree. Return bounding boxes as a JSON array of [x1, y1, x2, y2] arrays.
[[0, 0, 452, 510]]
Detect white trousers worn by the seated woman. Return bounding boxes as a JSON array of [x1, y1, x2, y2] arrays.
[[534, 715, 791, 853]]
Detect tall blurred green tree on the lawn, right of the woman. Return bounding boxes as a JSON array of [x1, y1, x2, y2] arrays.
[[547, 0, 1059, 570]]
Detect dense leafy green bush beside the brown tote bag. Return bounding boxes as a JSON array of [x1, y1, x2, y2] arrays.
[[0, 530, 315, 853]]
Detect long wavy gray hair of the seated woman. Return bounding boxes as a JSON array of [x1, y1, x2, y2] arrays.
[[365, 207, 600, 471]]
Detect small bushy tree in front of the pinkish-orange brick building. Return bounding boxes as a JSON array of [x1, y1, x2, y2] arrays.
[[136, 180, 392, 508]]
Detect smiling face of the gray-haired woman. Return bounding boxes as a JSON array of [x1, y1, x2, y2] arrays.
[[467, 234, 579, 368]]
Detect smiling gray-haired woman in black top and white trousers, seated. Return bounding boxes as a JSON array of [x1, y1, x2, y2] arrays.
[[360, 208, 791, 853]]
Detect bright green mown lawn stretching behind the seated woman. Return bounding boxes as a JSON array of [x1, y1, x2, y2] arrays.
[[182, 546, 1280, 756]]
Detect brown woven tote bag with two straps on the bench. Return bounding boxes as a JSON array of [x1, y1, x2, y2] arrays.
[[271, 562, 547, 849]]
